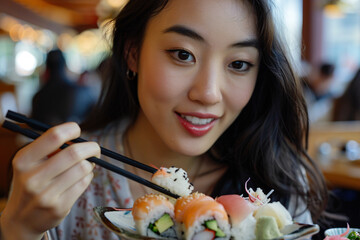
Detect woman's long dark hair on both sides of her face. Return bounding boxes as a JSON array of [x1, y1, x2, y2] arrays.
[[83, 0, 327, 220]]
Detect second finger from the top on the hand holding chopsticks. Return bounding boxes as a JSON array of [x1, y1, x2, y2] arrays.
[[27, 142, 100, 194]]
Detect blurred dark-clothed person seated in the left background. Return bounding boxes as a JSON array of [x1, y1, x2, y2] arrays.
[[31, 50, 95, 125]]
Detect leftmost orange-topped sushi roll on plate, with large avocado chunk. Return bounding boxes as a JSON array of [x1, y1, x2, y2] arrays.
[[132, 194, 177, 239]]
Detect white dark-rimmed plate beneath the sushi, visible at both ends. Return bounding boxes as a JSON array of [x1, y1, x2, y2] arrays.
[[94, 207, 319, 240]]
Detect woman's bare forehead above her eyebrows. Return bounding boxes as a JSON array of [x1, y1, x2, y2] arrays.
[[148, 0, 256, 42]]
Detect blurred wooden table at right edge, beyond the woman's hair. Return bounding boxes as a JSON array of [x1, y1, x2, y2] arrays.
[[308, 121, 360, 190]]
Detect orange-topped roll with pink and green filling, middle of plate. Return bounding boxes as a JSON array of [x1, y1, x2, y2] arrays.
[[175, 194, 230, 240]]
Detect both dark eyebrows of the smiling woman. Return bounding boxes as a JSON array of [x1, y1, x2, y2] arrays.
[[163, 25, 259, 49]]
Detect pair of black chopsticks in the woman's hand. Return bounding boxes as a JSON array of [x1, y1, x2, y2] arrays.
[[2, 111, 179, 198]]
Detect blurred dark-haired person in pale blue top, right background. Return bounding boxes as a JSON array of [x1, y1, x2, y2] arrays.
[[304, 63, 335, 123]]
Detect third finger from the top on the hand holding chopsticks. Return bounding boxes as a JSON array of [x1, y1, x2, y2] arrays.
[[34, 160, 94, 207]]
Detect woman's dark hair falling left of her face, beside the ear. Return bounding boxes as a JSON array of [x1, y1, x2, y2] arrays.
[[82, 0, 168, 130]]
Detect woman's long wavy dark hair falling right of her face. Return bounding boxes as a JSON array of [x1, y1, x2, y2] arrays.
[[214, 0, 328, 220]]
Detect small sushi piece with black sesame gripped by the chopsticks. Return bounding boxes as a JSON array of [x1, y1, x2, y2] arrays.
[[151, 167, 194, 196]]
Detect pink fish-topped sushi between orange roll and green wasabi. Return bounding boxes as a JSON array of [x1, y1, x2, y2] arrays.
[[216, 194, 258, 240]]
